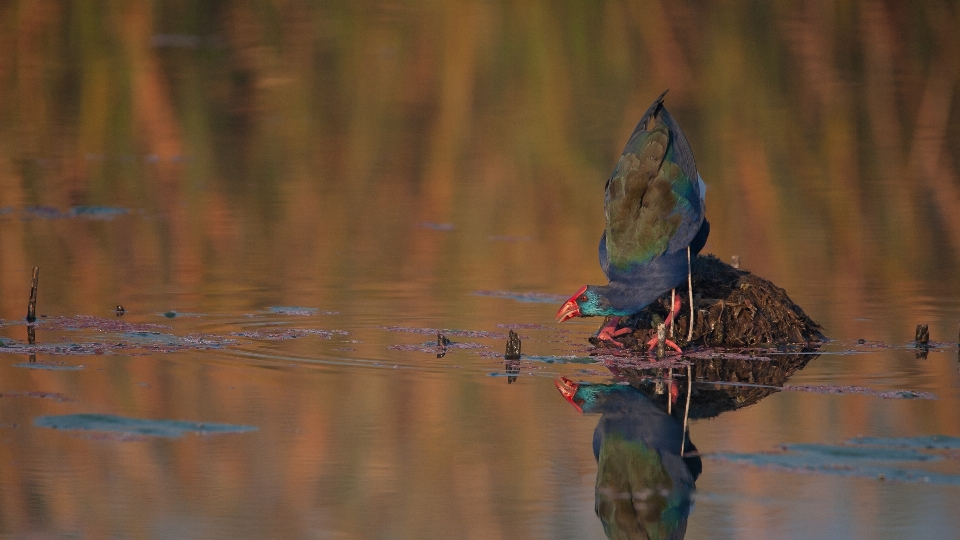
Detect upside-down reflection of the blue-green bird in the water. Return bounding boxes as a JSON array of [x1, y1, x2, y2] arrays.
[[556, 378, 702, 539]]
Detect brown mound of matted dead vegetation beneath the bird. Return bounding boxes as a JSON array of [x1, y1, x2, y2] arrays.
[[590, 255, 825, 350]]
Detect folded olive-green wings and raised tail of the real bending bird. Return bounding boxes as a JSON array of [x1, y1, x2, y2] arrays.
[[600, 95, 704, 279]]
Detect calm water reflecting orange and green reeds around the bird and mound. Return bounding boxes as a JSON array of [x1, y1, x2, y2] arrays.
[[0, 1, 960, 539]]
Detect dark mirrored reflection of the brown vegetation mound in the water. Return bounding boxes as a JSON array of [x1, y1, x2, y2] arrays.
[[610, 347, 819, 419]]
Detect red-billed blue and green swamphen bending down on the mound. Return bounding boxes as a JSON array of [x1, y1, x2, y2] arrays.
[[557, 91, 710, 352]]
